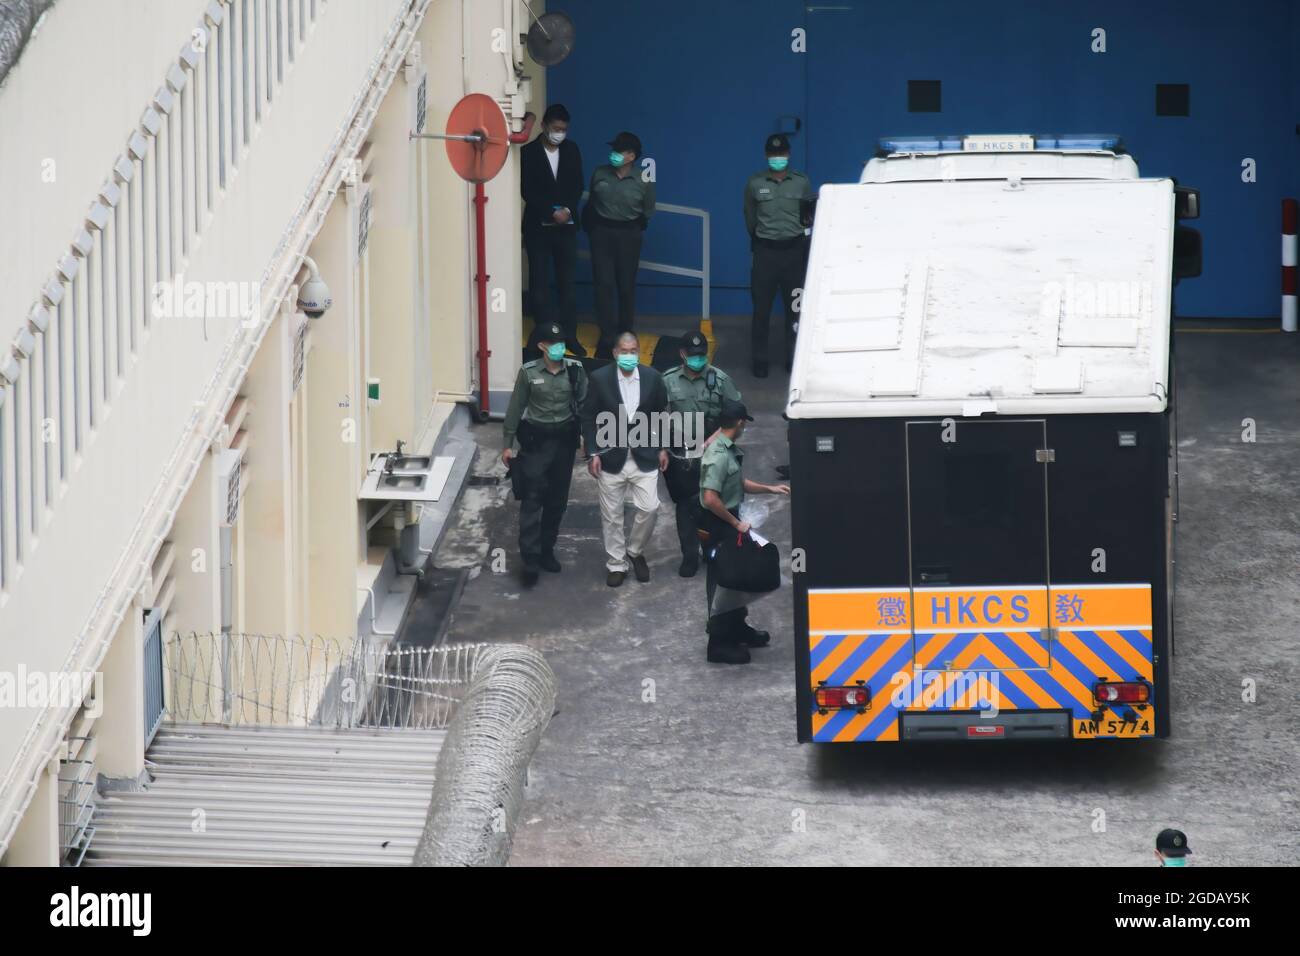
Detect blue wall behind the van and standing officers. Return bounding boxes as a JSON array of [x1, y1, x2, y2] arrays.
[[547, 0, 1300, 317]]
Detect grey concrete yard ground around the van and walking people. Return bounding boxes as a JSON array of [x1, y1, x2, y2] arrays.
[[411, 319, 1300, 866]]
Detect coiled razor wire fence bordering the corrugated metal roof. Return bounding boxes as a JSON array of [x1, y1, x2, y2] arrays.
[[165, 633, 555, 866]]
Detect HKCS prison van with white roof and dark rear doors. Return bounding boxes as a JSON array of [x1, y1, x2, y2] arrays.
[[787, 135, 1200, 743]]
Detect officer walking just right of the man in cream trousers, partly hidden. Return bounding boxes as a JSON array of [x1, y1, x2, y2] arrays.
[[663, 332, 740, 578]]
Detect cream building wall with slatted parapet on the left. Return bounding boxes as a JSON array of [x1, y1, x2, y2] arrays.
[[0, 0, 540, 862]]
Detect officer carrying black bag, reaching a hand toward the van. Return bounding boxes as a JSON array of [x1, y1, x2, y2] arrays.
[[699, 402, 790, 663]]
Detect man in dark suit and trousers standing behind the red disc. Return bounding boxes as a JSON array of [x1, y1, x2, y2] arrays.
[[519, 103, 586, 356]]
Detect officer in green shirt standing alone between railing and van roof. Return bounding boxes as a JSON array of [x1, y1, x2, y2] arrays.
[[745, 133, 813, 378]]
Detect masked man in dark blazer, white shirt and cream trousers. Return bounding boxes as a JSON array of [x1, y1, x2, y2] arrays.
[[582, 332, 670, 588]]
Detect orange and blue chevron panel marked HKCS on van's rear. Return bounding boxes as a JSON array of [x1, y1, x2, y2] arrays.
[[809, 584, 1154, 743]]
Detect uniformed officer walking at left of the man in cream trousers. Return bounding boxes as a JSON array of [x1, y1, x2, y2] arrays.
[[501, 323, 586, 584]]
